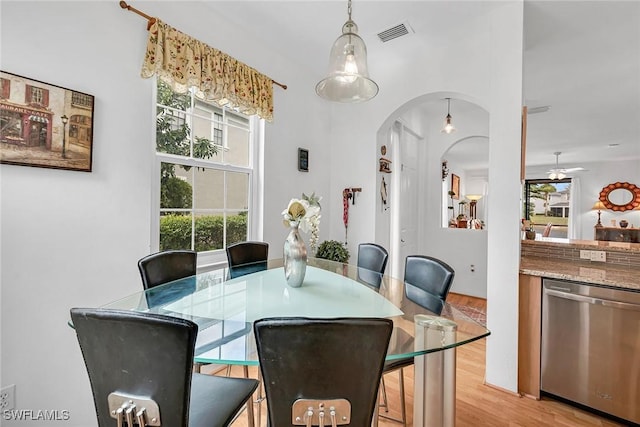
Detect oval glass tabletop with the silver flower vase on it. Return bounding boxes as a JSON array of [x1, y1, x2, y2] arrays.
[[102, 258, 490, 365]]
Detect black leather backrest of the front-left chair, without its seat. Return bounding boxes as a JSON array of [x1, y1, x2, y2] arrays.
[[71, 308, 198, 427]]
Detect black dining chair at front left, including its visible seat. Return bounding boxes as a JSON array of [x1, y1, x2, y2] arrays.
[[71, 308, 258, 427]]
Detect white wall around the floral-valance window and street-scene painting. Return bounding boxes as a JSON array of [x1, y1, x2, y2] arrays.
[[0, 1, 329, 427]]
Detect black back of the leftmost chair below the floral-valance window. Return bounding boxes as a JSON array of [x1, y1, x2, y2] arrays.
[[138, 250, 198, 289]]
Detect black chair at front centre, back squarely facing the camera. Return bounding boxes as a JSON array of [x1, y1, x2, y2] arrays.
[[253, 317, 393, 427]]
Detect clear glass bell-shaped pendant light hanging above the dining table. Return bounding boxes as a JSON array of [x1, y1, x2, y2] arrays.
[[316, 0, 378, 102]]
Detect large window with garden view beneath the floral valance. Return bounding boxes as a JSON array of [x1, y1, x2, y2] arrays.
[[154, 81, 254, 260]]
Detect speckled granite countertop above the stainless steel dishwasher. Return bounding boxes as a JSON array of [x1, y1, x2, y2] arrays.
[[520, 256, 640, 291]]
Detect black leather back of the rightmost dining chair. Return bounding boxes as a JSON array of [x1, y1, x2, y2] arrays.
[[404, 255, 455, 315]]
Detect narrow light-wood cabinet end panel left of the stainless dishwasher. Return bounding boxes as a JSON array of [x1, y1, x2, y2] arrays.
[[518, 274, 542, 399]]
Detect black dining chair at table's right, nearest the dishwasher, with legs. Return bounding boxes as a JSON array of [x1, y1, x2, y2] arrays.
[[381, 255, 455, 427]]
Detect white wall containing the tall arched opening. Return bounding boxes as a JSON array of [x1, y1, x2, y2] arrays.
[[331, 1, 523, 391]]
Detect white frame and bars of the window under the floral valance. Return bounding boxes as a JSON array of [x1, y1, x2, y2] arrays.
[[150, 79, 264, 268]]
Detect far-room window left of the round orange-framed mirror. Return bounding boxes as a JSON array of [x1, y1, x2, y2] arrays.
[[523, 179, 571, 237]]
